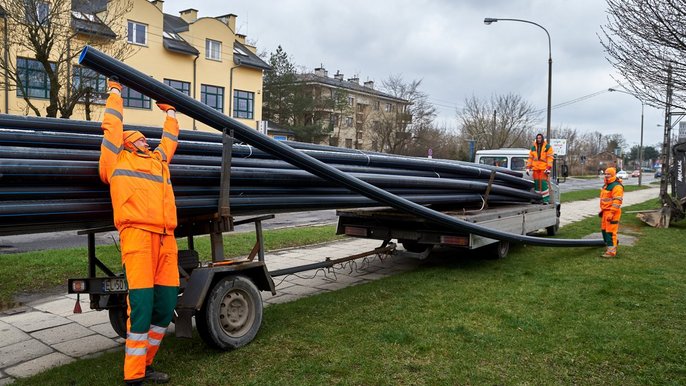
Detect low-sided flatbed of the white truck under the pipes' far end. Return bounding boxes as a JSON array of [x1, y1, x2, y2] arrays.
[[336, 201, 560, 259]]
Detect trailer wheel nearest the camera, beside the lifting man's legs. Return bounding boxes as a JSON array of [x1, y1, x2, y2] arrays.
[[195, 276, 262, 350]]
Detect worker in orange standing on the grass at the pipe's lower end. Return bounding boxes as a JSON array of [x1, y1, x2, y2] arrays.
[[598, 168, 624, 257]]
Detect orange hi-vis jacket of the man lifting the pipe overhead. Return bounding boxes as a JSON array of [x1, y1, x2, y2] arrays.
[[100, 93, 179, 235]]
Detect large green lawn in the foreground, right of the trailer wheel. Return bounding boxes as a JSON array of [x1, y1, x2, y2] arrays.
[[16, 200, 686, 385]]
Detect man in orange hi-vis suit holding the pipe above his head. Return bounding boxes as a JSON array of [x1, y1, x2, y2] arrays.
[[100, 80, 179, 385]]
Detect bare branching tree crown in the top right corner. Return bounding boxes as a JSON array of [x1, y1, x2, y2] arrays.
[[599, 0, 686, 108]]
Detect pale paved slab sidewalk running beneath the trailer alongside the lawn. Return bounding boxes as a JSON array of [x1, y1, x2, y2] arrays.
[[0, 188, 659, 385]]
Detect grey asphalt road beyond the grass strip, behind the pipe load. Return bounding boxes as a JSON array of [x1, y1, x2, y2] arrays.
[[0, 174, 654, 255]]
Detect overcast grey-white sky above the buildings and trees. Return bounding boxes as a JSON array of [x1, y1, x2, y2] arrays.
[[164, 0, 663, 146]]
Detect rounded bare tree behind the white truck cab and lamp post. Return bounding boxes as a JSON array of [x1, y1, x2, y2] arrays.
[[457, 93, 540, 149]]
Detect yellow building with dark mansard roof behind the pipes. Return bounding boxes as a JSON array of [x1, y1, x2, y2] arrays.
[[0, 0, 269, 130]]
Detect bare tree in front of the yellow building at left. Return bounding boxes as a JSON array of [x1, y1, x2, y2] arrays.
[[0, 0, 135, 119]]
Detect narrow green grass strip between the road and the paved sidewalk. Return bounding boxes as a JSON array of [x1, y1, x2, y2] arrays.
[[0, 225, 341, 310]]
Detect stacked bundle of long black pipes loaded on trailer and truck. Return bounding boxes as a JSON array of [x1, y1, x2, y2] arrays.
[[0, 115, 539, 235]]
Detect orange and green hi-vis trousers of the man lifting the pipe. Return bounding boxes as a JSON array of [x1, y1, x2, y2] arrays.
[[119, 227, 179, 381]]
